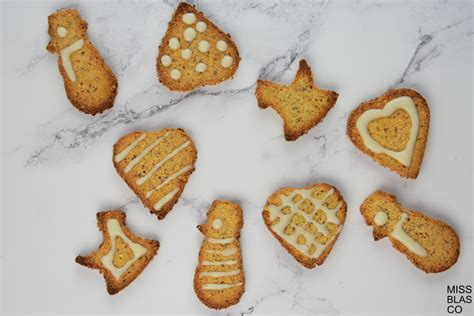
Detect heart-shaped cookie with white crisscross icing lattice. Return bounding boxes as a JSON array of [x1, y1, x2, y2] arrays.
[[262, 183, 347, 269]]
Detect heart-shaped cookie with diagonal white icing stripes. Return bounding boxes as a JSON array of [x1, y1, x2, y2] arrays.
[[113, 128, 197, 219]]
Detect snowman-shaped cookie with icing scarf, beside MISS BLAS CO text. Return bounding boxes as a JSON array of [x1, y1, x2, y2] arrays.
[[360, 191, 460, 273]]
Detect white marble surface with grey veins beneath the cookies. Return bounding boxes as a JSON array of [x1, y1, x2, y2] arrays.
[[1, 0, 473, 315]]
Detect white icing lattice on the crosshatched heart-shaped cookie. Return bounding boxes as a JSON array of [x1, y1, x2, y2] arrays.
[[267, 188, 342, 258]]
